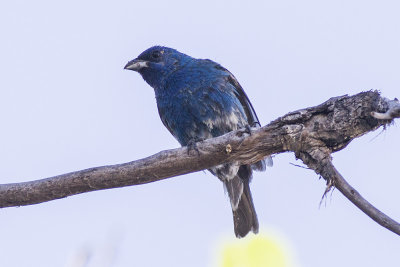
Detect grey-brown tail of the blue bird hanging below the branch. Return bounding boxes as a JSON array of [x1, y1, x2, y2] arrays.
[[224, 166, 258, 238]]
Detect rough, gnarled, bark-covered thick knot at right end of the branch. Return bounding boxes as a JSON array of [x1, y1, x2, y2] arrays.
[[275, 91, 400, 198]]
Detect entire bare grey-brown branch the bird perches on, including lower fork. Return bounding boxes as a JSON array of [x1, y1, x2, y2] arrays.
[[0, 91, 400, 237]]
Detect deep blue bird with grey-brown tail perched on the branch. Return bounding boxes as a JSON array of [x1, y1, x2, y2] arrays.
[[125, 46, 272, 238]]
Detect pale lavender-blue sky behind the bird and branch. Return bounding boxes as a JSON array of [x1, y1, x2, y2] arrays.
[[0, 0, 400, 267]]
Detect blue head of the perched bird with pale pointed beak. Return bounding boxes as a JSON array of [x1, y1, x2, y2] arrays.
[[125, 46, 192, 88]]
